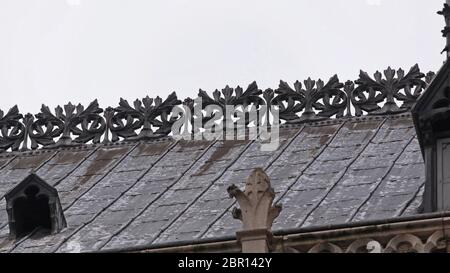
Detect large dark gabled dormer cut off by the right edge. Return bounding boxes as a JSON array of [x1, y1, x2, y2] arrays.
[[412, 61, 450, 212]]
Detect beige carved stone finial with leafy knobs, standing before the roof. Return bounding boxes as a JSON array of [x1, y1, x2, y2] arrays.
[[228, 168, 281, 253]]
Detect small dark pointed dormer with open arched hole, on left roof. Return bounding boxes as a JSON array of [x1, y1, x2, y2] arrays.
[[5, 174, 67, 239]]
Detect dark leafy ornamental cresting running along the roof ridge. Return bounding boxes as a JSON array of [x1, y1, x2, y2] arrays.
[[0, 65, 434, 152]]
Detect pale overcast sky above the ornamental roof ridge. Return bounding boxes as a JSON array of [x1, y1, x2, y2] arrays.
[[0, 0, 445, 113]]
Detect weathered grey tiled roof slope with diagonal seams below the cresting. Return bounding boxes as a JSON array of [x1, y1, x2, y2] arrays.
[[0, 111, 424, 252]]
